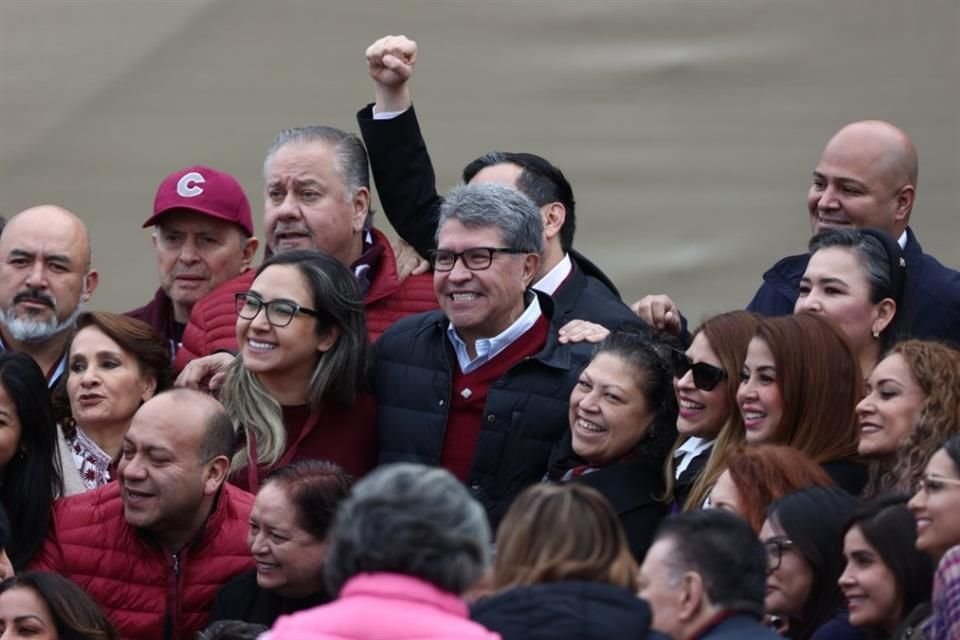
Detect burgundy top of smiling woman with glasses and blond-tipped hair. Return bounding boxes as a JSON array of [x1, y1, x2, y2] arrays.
[[230, 393, 379, 491]]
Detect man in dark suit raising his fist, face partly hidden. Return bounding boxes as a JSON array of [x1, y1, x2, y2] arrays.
[[357, 36, 636, 336]]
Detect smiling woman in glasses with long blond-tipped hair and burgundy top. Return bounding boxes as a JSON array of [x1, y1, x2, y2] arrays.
[[223, 250, 377, 491]]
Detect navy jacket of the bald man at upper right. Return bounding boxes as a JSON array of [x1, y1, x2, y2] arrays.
[[747, 227, 960, 345]]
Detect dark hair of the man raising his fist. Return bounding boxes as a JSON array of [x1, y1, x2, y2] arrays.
[[463, 151, 577, 252]]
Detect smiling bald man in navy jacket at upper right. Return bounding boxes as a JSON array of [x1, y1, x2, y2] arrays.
[[747, 120, 960, 345]]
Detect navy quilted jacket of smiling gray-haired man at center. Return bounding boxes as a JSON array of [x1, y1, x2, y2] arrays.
[[374, 292, 593, 527]]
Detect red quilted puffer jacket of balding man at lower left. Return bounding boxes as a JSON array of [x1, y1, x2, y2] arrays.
[[31, 482, 253, 640]]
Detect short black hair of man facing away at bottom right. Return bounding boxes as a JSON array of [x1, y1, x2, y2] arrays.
[[656, 509, 767, 616]]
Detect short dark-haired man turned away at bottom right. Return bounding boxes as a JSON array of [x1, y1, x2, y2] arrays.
[[638, 509, 780, 640]]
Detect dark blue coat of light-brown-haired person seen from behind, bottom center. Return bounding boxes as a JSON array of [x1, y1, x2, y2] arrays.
[[470, 582, 665, 640]]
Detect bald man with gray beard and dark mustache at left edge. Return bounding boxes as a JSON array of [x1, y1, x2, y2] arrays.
[[0, 205, 99, 387]]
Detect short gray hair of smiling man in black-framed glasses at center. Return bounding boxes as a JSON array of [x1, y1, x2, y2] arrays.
[[437, 183, 543, 255]]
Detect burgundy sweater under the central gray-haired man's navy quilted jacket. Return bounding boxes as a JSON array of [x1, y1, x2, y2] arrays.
[[440, 316, 550, 482]]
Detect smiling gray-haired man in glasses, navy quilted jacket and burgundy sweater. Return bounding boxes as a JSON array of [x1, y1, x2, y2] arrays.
[[374, 184, 591, 526]]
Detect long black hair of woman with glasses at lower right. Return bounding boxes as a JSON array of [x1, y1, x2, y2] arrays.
[[767, 487, 857, 638]]
